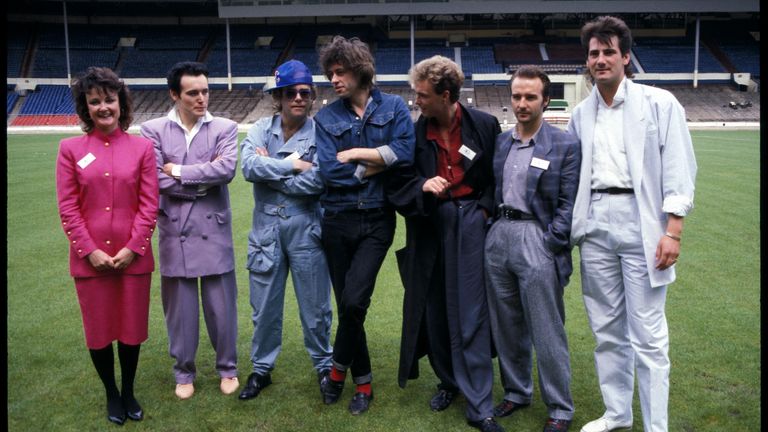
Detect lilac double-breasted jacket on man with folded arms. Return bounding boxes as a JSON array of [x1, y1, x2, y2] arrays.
[[141, 117, 237, 278]]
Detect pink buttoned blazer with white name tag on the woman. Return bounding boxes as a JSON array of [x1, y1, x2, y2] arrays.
[[56, 129, 158, 277]]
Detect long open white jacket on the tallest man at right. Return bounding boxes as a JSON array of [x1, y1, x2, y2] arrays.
[[568, 78, 697, 287]]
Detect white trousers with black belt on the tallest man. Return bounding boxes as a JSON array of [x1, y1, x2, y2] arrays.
[[580, 194, 670, 432]]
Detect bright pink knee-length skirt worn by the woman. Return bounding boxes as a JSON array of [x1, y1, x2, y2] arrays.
[[75, 273, 152, 349]]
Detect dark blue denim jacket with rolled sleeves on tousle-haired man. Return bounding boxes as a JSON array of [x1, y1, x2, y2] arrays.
[[315, 88, 415, 211]]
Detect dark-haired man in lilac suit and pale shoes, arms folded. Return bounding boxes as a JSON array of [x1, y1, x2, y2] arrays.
[[141, 62, 239, 399]]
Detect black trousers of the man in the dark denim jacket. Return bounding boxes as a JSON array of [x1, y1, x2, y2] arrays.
[[322, 208, 396, 384]]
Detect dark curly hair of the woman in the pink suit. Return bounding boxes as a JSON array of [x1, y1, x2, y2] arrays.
[[72, 66, 133, 133]]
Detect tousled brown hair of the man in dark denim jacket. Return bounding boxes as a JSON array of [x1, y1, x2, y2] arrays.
[[318, 36, 376, 89]]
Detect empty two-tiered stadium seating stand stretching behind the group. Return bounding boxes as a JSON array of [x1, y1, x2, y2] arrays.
[[6, 11, 760, 125]]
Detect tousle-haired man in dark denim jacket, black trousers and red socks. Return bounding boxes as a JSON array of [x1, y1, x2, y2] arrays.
[[315, 36, 415, 414]]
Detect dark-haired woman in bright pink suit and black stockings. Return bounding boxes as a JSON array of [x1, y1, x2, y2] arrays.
[[56, 67, 158, 425]]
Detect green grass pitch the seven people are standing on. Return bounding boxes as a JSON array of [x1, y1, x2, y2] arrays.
[[6, 131, 761, 432]]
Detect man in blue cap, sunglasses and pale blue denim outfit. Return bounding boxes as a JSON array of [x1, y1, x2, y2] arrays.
[[239, 60, 331, 400]]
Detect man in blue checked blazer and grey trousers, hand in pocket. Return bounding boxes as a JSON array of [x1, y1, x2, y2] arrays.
[[485, 67, 581, 432]]
